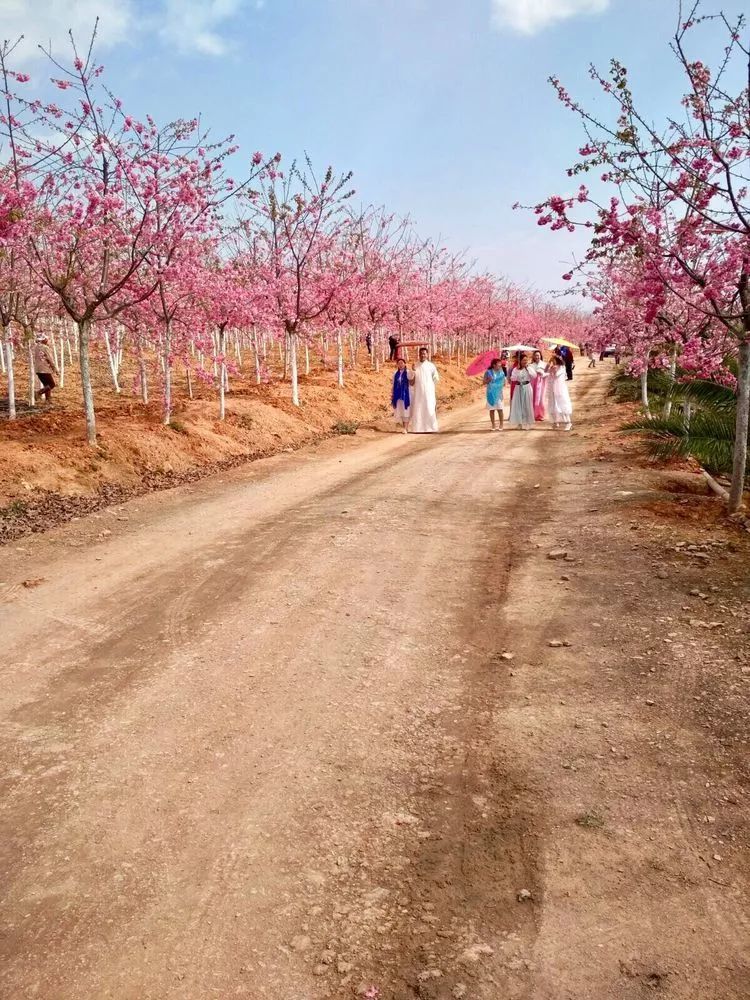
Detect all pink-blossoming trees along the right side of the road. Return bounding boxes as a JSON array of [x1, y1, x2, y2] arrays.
[[535, 0, 750, 512]]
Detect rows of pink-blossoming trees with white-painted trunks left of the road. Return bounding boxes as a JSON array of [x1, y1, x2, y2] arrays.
[[0, 32, 586, 445]]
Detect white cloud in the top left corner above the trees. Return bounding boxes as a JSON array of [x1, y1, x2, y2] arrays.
[[0, 0, 134, 64]]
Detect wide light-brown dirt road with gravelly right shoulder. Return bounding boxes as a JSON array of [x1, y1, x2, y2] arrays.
[[0, 372, 750, 1000]]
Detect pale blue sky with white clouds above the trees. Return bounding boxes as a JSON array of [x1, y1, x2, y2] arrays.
[[7, 0, 744, 290]]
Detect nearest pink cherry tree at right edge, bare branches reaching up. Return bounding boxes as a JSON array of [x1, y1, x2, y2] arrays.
[[536, 0, 750, 512]]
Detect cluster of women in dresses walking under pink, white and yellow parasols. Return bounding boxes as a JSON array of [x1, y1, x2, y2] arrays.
[[484, 351, 573, 431]]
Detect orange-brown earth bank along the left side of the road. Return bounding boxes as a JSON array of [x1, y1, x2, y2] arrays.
[[0, 360, 473, 542]]
